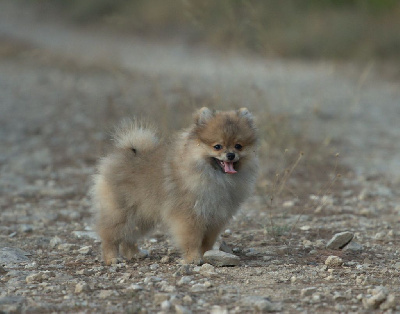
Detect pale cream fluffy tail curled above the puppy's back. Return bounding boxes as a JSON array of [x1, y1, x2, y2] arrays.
[[113, 119, 160, 153]]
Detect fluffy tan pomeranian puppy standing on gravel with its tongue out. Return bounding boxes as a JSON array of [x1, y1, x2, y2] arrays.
[[92, 107, 258, 265]]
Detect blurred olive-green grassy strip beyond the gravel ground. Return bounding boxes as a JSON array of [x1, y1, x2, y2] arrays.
[[42, 0, 400, 61]]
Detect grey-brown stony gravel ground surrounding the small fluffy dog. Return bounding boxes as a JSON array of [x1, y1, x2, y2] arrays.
[[0, 2, 400, 313]]
